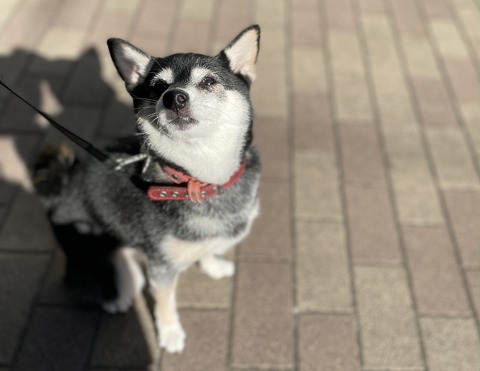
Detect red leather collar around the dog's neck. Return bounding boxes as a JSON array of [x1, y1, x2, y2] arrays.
[[147, 161, 247, 202]]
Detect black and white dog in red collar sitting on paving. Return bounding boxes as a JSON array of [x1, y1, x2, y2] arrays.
[[34, 25, 260, 353]]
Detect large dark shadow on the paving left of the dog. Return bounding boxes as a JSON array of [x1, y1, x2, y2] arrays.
[[0, 48, 158, 369]]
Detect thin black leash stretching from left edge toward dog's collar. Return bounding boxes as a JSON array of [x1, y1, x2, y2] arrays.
[[0, 79, 114, 168]]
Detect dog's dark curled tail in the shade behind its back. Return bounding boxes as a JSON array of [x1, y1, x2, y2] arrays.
[[33, 144, 75, 206]]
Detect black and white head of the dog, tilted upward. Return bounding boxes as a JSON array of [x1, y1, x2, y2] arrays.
[[108, 26, 260, 184]]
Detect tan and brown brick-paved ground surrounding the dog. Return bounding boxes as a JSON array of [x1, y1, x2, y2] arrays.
[[0, 0, 480, 371]]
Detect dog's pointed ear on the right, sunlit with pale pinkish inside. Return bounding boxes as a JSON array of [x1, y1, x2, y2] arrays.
[[220, 25, 260, 82]]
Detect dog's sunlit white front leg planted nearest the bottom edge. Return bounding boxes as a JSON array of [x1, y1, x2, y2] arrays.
[[152, 275, 186, 353]]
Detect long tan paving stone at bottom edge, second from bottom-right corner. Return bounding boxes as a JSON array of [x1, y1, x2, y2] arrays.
[[355, 267, 423, 369]]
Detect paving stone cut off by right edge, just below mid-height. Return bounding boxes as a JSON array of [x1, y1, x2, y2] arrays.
[[443, 191, 480, 268]]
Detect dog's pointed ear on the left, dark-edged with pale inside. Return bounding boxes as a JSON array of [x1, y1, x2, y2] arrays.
[[107, 39, 153, 91]]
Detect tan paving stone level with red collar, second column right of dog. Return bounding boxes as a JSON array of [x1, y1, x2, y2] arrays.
[[294, 151, 343, 220]]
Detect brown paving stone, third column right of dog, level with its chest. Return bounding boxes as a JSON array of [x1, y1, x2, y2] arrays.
[[345, 183, 402, 265]]
